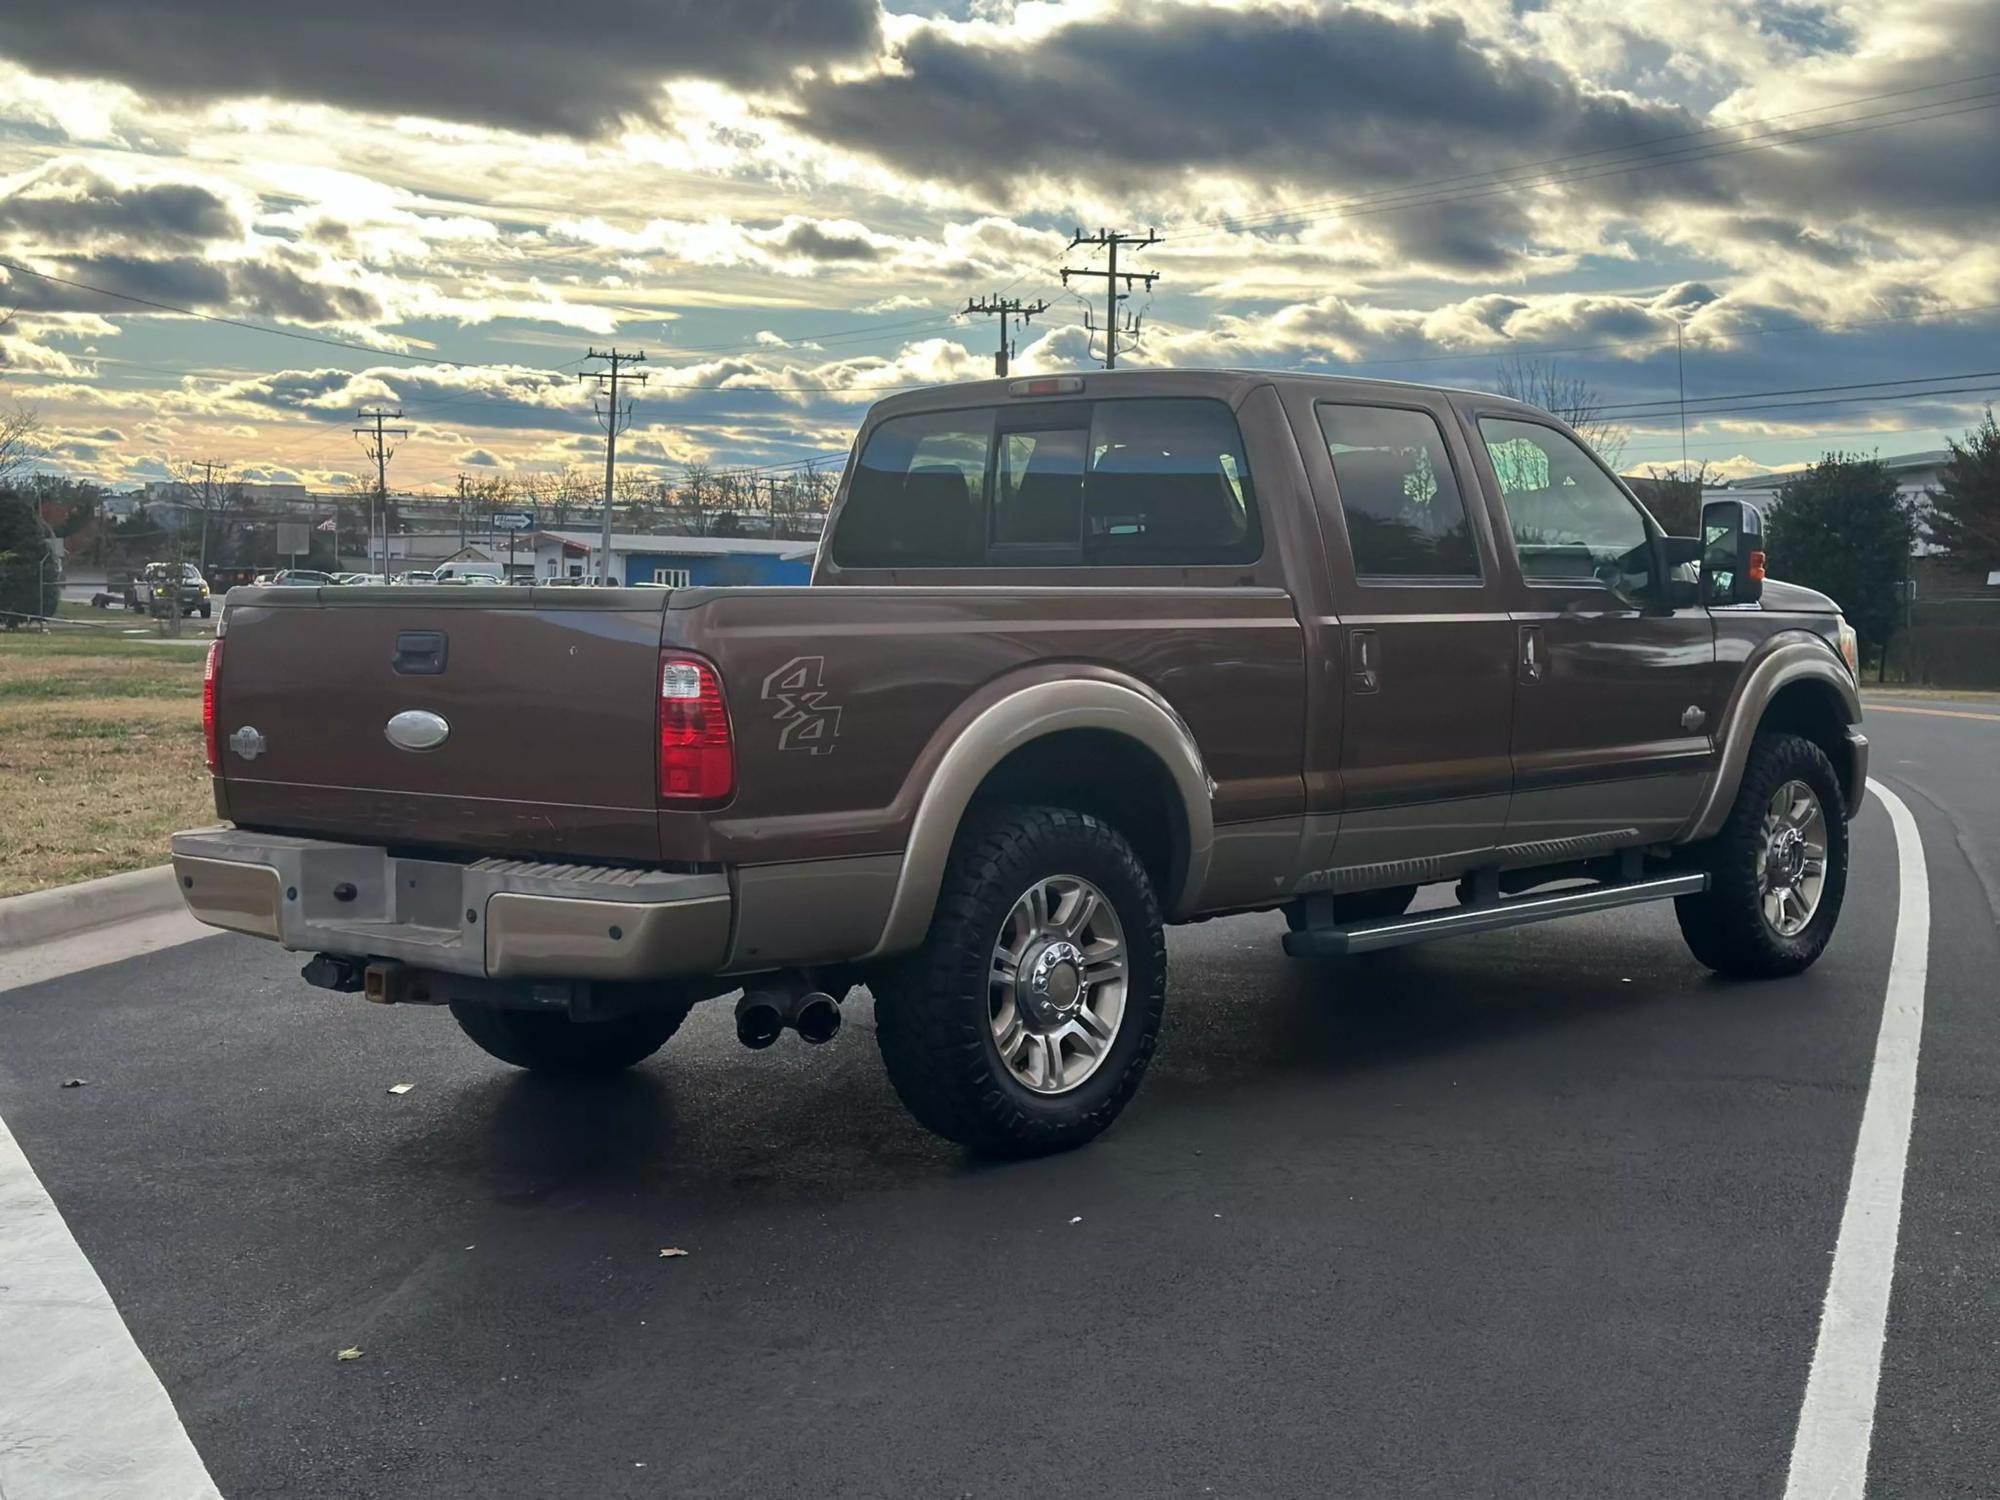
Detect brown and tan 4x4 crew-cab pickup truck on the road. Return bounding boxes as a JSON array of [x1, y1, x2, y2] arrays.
[[174, 370, 1868, 1152]]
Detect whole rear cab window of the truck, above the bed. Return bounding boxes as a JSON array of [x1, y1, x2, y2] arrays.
[[832, 398, 1264, 568]]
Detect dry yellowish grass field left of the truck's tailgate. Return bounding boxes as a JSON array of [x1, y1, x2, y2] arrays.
[[0, 632, 214, 896]]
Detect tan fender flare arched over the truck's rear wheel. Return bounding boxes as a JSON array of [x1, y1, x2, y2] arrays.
[[864, 676, 1216, 958]]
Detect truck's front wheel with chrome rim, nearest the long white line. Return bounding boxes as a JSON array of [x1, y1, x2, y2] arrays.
[[1674, 734, 1848, 980]]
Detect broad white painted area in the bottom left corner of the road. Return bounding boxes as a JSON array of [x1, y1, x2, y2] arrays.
[[0, 1120, 220, 1500]]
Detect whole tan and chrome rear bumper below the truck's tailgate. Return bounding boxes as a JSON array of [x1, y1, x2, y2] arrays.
[[174, 828, 732, 980]]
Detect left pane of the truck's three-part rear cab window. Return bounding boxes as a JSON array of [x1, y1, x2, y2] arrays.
[[834, 410, 994, 568]]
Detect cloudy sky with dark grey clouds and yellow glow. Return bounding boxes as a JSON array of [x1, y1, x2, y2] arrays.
[[0, 0, 2000, 486]]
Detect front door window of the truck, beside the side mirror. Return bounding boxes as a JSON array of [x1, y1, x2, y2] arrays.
[[1480, 416, 1652, 594]]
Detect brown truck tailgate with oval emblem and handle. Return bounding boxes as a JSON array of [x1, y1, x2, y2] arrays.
[[216, 586, 666, 860]]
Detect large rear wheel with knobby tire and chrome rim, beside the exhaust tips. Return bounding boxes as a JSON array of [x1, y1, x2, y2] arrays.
[[872, 808, 1166, 1156]]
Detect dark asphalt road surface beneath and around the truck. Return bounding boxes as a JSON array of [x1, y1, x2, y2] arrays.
[[0, 700, 2000, 1500]]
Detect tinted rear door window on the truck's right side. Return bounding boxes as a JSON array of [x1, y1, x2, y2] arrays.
[[1318, 406, 1480, 578]]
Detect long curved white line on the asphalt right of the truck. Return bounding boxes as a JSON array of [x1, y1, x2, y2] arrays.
[[1784, 780, 1930, 1500]]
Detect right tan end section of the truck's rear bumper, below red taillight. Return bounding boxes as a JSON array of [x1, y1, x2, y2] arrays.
[[486, 892, 730, 980]]
